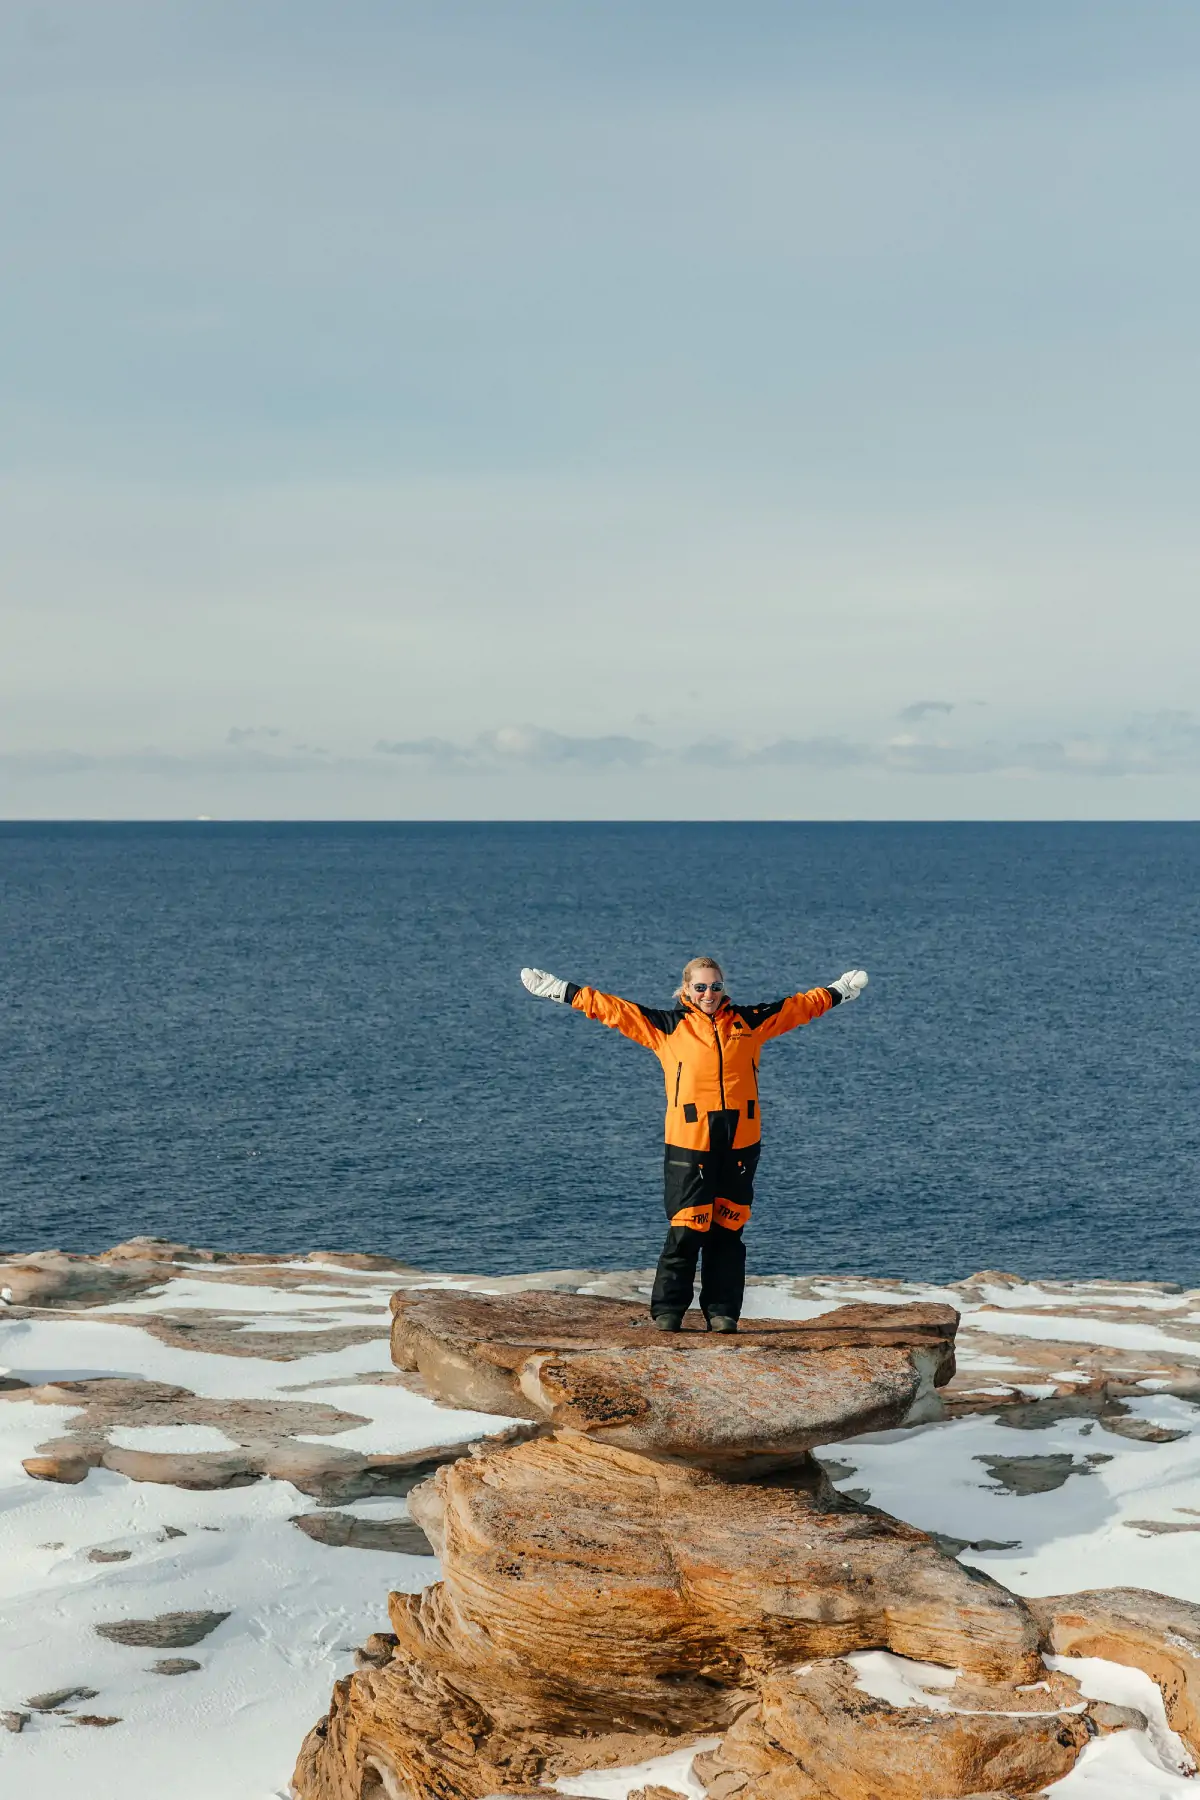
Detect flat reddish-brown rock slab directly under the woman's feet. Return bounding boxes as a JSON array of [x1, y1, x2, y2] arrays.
[[392, 1291, 957, 1476]]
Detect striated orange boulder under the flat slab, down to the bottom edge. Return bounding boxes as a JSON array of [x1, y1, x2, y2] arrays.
[[295, 1438, 1040, 1800]]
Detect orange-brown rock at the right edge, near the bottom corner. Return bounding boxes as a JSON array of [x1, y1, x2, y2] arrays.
[[1027, 1588, 1200, 1755]]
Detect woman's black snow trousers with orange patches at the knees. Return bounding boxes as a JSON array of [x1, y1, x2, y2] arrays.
[[649, 1143, 759, 1319]]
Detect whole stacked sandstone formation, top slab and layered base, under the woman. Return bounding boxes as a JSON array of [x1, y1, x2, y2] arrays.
[[287, 1294, 1090, 1800]]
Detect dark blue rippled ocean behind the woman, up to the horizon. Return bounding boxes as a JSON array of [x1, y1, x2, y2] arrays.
[[0, 824, 1200, 1283]]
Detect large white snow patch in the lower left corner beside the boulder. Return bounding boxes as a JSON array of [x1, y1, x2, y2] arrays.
[[0, 1402, 435, 1800]]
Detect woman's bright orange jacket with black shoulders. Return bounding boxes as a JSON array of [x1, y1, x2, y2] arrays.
[[565, 981, 842, 1150]]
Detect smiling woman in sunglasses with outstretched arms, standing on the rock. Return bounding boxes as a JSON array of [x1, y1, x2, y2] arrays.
[[522, 956, 867, 1332]]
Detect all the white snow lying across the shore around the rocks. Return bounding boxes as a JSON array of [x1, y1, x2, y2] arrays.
[[0, 1262, 1200, 1800]]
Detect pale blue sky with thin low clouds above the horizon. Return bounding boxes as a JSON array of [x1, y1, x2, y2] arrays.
[[0, 0, 1200, 819]]
